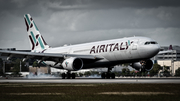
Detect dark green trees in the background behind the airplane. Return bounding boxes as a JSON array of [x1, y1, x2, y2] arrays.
[[0, 58, 180, 76]]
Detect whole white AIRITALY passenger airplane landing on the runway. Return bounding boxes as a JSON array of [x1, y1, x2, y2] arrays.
[[0, 14, 160, 79]]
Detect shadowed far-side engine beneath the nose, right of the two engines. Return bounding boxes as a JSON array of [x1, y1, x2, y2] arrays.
[[131, 60, 153, 71]]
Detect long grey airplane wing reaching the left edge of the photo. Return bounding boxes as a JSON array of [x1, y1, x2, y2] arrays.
[[0, 50, 103, 62]]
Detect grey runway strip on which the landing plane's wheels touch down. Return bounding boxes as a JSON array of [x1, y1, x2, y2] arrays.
[[0, 78, 180, 84]]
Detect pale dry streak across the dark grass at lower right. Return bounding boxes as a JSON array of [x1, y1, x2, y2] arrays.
[[98, 92, 174, 95]]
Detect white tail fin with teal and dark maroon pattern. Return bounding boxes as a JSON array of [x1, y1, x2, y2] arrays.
[[24, 14, 49, 52]]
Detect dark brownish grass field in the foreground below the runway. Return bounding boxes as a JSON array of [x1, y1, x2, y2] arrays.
[[0, 83, 180, 101]]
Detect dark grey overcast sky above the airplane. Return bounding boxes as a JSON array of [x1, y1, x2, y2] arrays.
[[0, 0, 180, 49]]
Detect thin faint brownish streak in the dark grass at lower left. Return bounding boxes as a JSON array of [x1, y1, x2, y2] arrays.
[[5, 93, 64, 95]]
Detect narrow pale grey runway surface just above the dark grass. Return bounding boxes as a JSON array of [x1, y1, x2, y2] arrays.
[[0, 79, 180, 83]]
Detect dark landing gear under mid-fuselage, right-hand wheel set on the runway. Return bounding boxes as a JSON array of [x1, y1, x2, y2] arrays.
[[101, 67, 115, 79]]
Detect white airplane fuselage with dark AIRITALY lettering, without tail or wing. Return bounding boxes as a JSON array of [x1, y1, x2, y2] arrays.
[[44, 37, 160, 68]]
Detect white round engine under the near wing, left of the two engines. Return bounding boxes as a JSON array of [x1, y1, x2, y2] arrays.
[[62, 57, 83, 71]]
